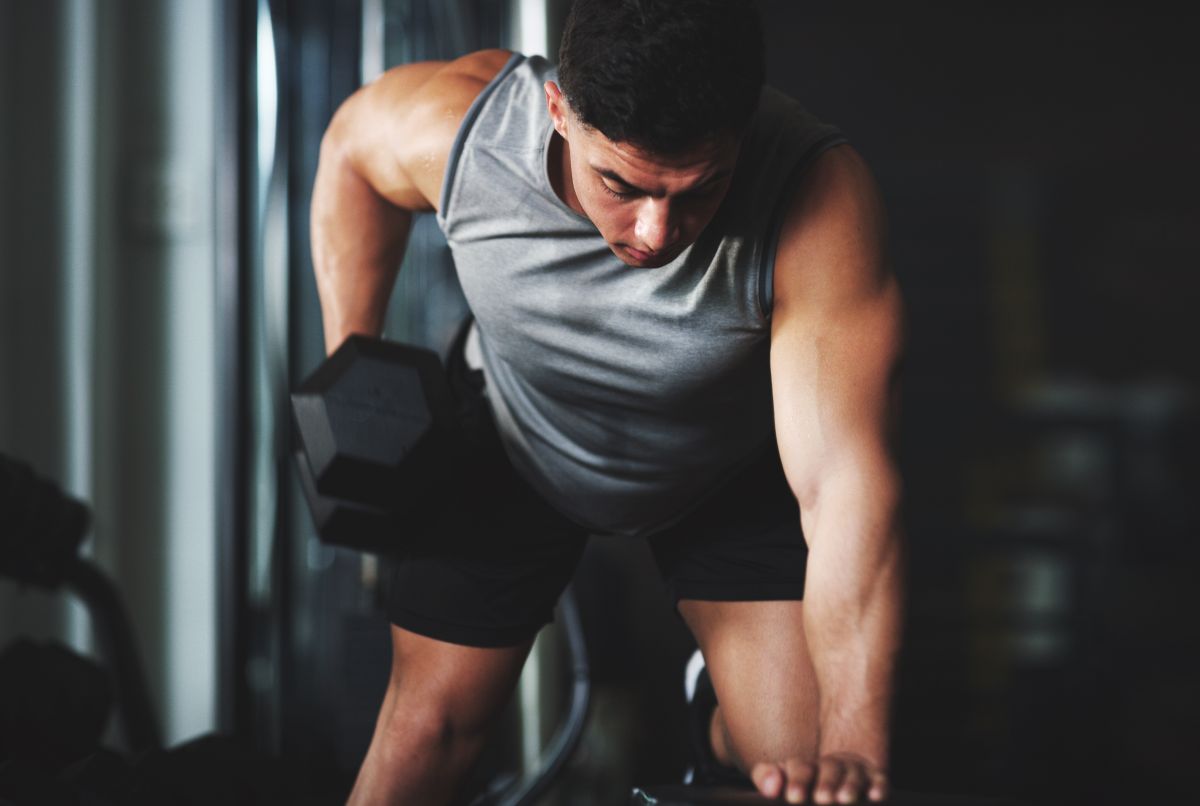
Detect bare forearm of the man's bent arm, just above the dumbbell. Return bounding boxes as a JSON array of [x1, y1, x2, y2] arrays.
[[312, 133, 413, 353]]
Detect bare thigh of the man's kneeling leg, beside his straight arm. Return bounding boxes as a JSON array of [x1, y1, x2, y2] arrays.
[[679, 600, 818, 775]]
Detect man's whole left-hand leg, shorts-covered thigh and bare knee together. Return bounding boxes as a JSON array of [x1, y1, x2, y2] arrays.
[[350, 327, 587, 806]]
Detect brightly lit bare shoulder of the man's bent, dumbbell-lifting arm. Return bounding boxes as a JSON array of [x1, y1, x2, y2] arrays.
[[323, 49, 512, 210]]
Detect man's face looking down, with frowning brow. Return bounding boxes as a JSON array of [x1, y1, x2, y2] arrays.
[[546, 83, 738, 269]]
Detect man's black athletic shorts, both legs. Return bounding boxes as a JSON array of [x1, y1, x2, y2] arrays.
[[386, 321, 808, 646]]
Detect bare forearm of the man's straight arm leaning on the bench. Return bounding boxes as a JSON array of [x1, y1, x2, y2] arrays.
[[804, 470, 904, 769]]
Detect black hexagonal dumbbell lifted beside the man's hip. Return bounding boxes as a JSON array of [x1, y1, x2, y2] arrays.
[[292, 336, 454, 552]]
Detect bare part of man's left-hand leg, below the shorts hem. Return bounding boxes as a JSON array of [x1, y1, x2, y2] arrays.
[[349, 625, 533, 806]]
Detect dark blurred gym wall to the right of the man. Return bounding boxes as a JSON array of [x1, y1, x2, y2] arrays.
[[763, 1, 1200, 804]]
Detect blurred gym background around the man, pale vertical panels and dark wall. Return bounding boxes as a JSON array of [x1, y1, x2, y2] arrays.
[[0, 0, 1200, 804]]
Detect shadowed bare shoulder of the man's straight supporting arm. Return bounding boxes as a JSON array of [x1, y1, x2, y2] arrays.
[[773, 145, 895, 317]]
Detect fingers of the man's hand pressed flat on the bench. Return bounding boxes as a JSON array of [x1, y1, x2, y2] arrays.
[[750, 756, 888, 804]]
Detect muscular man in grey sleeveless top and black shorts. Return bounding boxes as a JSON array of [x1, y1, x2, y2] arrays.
[[312, 0, 902, 804]]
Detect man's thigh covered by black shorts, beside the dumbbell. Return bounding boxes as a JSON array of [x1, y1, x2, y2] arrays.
[[385, 316, 587, 648]]
